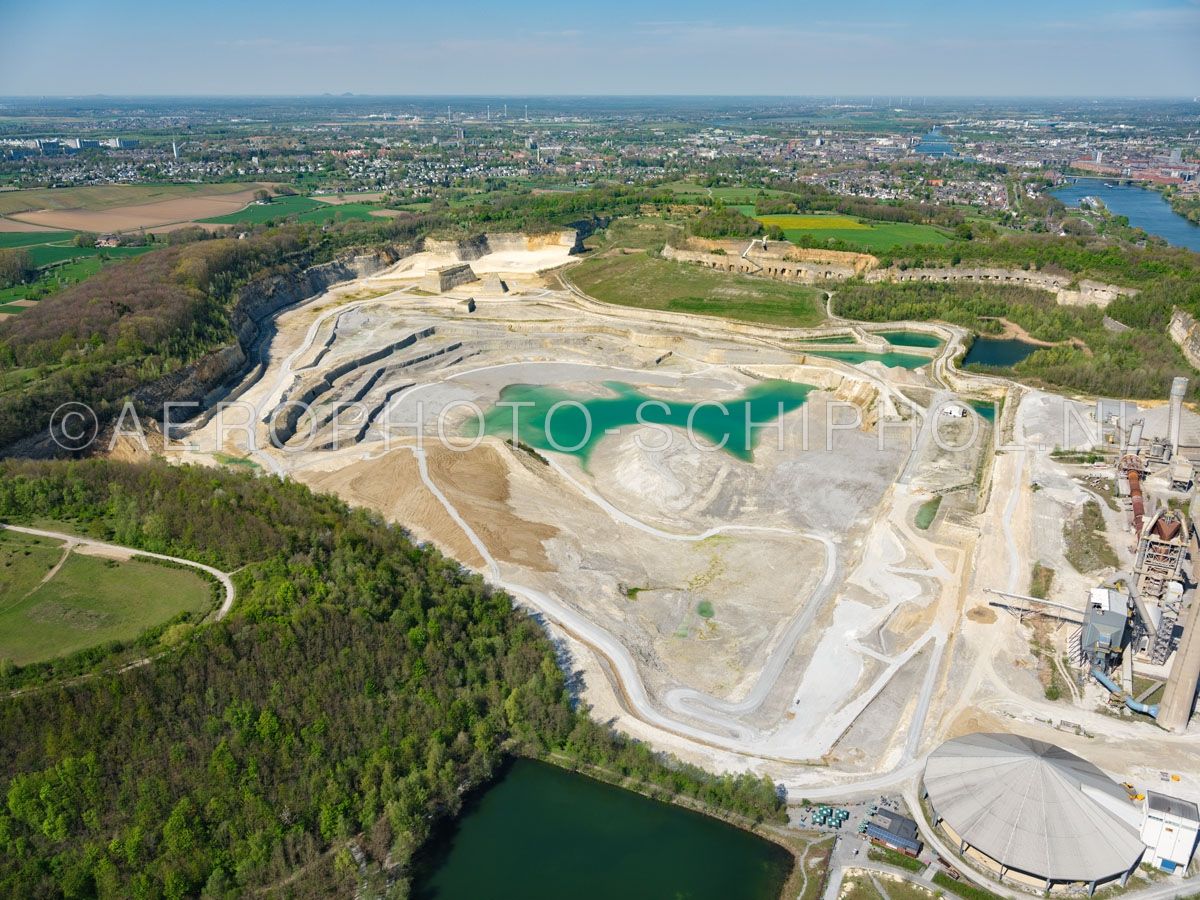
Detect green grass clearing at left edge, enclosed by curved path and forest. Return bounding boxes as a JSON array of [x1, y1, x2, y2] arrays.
[[0, 532, 212, 666]]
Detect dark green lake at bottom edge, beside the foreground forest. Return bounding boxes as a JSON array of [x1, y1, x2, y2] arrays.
[[413, 760, 792, 900]]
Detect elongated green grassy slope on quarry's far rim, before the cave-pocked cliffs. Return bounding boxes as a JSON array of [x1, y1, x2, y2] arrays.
[[566, 253, 824, 328]]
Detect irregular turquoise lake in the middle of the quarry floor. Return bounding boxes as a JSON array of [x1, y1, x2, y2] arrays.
[[467, 380, 815, 463]]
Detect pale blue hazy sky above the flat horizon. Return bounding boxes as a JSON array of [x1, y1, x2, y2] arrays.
[[0, 0, 1200, 96]]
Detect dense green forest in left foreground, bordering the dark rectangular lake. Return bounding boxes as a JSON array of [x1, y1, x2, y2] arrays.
[[0, 461, 784, 898]]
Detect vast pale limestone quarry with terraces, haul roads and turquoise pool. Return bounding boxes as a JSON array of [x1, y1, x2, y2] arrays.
[[169, 232, 1200, 825]]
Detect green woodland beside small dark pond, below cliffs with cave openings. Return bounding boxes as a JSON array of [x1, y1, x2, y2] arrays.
[[834, 282, 1194, 398]]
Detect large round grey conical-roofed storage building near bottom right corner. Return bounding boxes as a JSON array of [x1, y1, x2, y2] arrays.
[[924, 734, 1146, 890]]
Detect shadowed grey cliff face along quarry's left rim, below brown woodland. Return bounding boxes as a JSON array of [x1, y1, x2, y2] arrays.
[[133, 248, 400, 422]]
